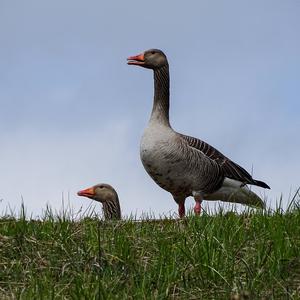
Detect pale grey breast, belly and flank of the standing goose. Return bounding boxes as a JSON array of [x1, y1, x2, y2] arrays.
[[140, 124, 222, 196]]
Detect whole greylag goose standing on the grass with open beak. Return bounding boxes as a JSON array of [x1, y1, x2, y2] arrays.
[[127, 49, 270, 217]]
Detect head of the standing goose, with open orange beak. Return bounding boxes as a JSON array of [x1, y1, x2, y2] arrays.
[[127, 49, 168, 70]]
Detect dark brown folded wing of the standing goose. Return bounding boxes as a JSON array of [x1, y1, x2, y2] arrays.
[[180, 134, 270, 188]]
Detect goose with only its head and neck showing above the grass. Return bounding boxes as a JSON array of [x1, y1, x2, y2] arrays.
[[77, 183, 121, 220]]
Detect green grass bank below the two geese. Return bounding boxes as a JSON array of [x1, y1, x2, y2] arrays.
[[0, 203, 300, 299]]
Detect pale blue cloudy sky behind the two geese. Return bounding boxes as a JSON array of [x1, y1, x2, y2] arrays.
[[0, 0, 300, 217]]
